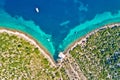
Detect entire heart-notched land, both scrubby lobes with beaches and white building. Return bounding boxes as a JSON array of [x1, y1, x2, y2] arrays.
[[0, 23, 120, 80]]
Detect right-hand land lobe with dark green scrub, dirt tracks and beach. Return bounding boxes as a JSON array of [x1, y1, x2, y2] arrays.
[[62, 23, 120, 80]]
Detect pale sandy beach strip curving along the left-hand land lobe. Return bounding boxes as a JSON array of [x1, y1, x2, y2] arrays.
[[0, 28, 56, 67]]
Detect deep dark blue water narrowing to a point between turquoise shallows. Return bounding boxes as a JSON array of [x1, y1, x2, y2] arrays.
[[2, 0, 120, 58]]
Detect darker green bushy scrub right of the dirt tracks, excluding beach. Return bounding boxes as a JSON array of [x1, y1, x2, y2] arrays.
[[69, 26, 120, 80]]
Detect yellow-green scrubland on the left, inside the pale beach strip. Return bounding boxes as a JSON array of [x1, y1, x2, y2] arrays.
[[0, 32, 60, 80]]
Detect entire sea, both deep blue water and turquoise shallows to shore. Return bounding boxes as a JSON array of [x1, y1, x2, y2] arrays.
[[0, 0, 120, 60]]
